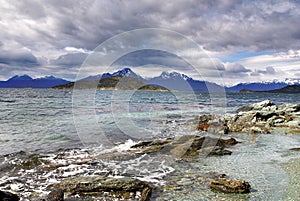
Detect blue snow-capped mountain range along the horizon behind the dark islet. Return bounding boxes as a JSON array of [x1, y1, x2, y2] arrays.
[[0, 68, 300, 92]]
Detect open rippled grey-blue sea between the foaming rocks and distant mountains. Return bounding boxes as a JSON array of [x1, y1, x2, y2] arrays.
[[0, 89, 300, 155]]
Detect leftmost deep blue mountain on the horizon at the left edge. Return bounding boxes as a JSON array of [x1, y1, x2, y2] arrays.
[[0, 75, 69, 88]]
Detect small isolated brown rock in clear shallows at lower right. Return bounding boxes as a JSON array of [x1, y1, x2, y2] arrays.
[[210, 178, 251, 193]]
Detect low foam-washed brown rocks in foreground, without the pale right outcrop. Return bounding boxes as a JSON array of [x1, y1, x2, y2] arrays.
[[0, 135, 250, 201]]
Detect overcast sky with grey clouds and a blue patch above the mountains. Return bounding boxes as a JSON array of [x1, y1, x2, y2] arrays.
[[0, 0, 300, 85]]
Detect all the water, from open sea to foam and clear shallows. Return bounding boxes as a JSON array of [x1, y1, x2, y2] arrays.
[[0, 89, 300, 201]]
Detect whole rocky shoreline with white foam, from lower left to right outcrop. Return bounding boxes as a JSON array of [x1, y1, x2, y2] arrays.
[[0, 101, 300, 201]]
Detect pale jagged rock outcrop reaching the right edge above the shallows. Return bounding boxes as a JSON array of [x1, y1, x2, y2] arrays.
[[198, 100, 300, 134]]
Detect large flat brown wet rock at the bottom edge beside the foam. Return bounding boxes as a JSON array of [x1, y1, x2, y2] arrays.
[[57, 176, 152, 201]]
